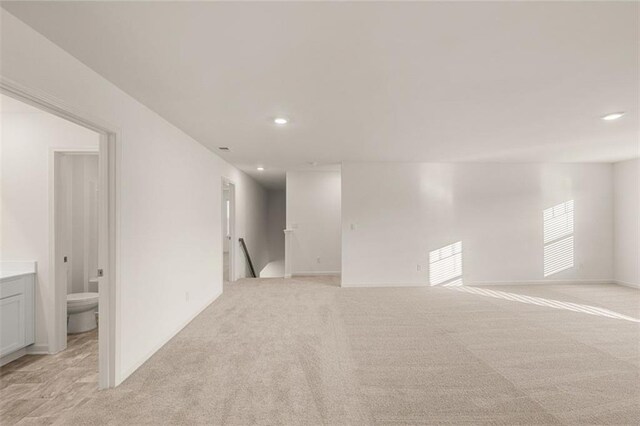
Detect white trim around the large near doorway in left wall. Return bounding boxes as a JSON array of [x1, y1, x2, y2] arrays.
[[0, 76, 122, 388]]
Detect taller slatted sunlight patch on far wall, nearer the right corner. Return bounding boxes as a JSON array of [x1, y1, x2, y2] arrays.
[[542, 200, 574, 277]]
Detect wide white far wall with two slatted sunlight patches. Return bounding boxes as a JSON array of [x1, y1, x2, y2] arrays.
[[342, 163, 613, 286]]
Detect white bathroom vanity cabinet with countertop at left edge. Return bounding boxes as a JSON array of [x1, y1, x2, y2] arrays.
[[0, 262, 36, 357]]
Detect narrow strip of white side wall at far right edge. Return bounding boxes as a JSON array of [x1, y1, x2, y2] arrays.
[[613, 158, 640, 287]]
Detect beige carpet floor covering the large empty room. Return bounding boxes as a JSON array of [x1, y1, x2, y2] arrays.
[[12, 278, 640, 425]]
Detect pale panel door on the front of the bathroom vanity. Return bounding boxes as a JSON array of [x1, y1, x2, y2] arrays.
[[0, 293, 25, 356]]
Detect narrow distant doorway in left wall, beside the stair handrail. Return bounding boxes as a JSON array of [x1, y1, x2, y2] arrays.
[[221, 178, 237, 285]]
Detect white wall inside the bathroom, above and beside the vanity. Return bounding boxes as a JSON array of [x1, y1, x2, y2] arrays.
[[0, 106, 99, 351]]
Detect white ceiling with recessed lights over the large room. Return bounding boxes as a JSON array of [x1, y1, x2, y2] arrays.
[[3, 2, 639, 186]]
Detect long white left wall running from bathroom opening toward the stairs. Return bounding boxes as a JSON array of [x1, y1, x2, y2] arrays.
[[0, 10, 268, 383]]
